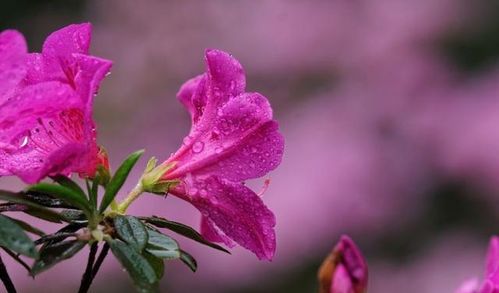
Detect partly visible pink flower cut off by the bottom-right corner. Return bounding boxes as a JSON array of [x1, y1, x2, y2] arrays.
[[456, 236, 499, 293]]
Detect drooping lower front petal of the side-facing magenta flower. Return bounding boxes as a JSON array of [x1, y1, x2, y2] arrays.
[[176, 176, 276, 260]]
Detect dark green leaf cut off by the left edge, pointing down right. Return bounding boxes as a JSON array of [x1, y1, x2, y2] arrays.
[[0, 215, 38, 258]]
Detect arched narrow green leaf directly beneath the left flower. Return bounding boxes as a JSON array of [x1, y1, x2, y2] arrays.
[[29, 183, 92, 216]]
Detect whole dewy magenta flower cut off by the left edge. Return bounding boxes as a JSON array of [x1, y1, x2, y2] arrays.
[[0, 24, 111, 183]]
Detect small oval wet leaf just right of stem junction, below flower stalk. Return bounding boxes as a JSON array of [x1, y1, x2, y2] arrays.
[[114, 216, 149, 252]]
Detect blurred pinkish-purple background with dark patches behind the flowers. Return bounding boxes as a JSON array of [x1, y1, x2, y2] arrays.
[[0, 0, 499, 293]]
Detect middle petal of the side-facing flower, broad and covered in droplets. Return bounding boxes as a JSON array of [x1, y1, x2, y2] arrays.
[[167, 93, 284, 181]]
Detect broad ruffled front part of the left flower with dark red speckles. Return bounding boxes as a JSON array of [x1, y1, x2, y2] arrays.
[[0, 82, 91, 183]]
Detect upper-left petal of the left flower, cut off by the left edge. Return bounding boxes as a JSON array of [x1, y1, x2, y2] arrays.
[[0, 30, 27, 101]]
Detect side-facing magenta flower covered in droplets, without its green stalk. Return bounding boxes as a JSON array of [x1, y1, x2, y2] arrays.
[[162, 50, 284, 260]]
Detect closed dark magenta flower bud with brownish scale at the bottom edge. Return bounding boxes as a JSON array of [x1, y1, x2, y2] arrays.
[[318, 236, 368, 293]]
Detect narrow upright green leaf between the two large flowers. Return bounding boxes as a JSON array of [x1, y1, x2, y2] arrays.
[[99, 150, 144, 213]]
